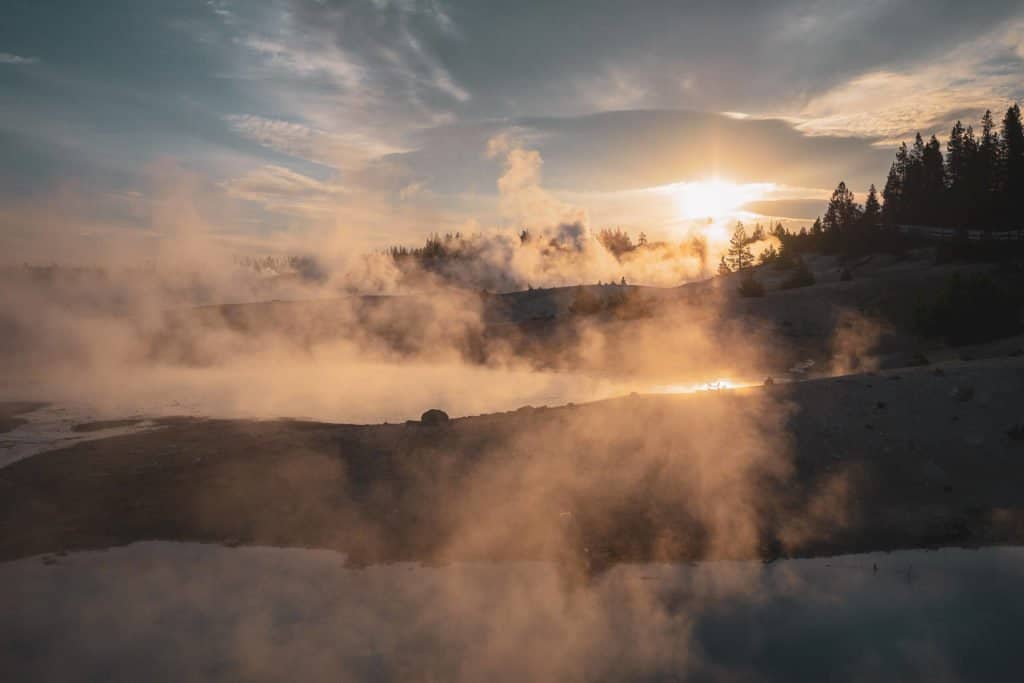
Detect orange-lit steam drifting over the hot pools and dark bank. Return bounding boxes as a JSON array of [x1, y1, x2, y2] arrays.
[[0, 143, 868, 680]]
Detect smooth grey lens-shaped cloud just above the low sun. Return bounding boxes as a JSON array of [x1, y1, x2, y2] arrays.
[[380, 111, 892, 194]]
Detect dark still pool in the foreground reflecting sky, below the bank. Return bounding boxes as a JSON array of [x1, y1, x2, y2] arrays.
[[0, 543, 1024, 681]]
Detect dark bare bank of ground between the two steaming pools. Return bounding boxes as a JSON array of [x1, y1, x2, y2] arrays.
[[0, 358, 1024, 571]]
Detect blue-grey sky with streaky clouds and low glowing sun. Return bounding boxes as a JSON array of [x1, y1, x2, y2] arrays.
[[0, 0, 1024, 260]]
